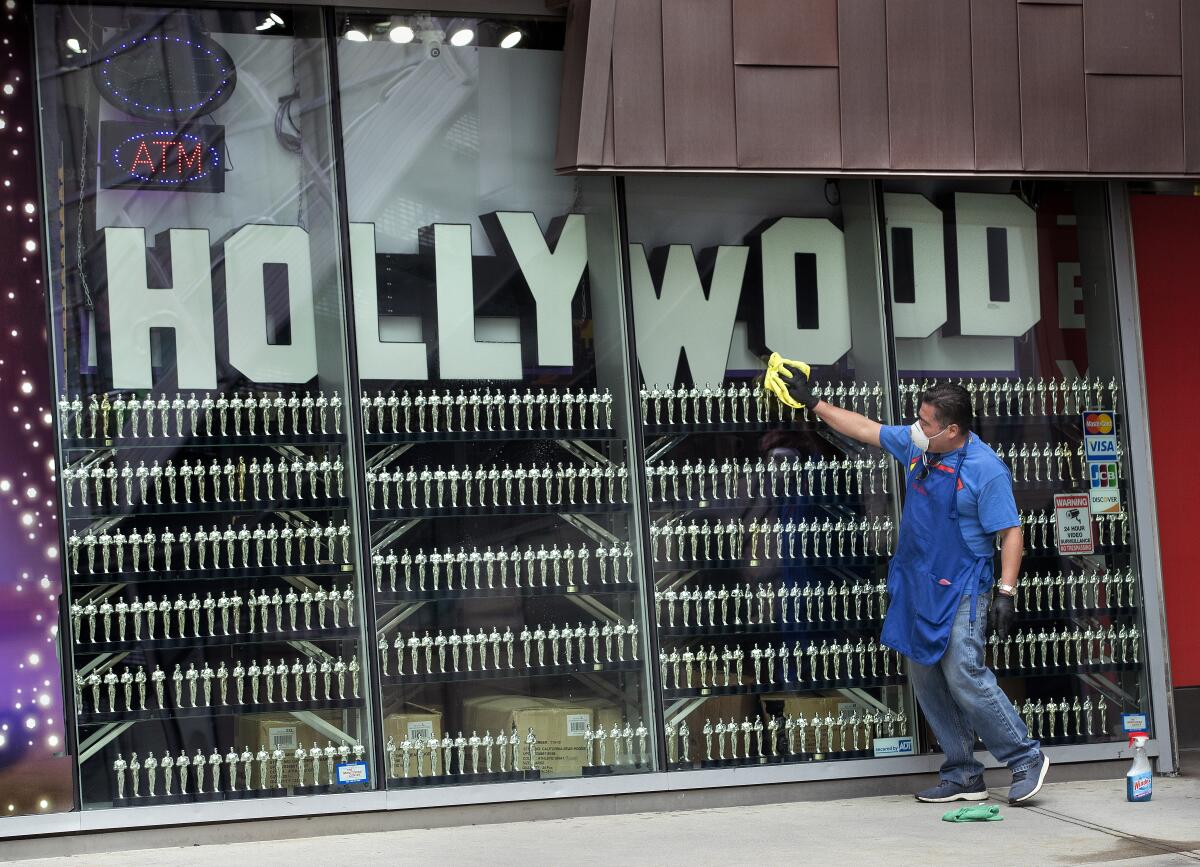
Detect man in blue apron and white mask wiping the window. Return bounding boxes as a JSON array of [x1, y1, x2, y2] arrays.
[[763, 353, 1050, 803]]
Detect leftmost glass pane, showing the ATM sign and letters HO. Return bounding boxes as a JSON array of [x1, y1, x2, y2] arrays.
[[37, 5, 372, 808]]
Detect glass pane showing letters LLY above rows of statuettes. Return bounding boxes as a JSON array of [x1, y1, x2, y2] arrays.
[[337, 13, 654, 788]]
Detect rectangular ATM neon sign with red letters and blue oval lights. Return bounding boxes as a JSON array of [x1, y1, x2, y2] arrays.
[[101, 121, 224, 192]]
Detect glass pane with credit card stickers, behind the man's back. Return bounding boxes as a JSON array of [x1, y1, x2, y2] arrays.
[[883, 180, 1150, 745]]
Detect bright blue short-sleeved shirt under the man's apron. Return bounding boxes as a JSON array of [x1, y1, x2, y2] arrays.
[[880, 425, 1021, 557]]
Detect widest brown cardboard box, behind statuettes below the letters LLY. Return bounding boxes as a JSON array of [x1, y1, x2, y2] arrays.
[[463, 695, 593, 777]]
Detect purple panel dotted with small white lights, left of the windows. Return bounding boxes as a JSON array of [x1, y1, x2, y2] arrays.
[[0, 0, 72, 815]]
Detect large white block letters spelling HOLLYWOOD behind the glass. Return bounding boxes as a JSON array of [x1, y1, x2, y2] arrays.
[[103, 193, 1039, 389]]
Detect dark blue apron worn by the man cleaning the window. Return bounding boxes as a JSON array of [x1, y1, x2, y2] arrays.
[[881, 440, 991, 665]]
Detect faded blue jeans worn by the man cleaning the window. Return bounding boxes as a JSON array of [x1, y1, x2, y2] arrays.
[[905, 594, 1040, 785]]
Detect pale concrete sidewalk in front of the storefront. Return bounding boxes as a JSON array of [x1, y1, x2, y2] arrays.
[[9, 778, 1200, 867]]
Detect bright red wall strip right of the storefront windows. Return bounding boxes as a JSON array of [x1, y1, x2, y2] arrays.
[[1130, 196, 1200, 687]]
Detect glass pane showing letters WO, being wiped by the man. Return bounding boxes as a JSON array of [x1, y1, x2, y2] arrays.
[[628, 177, 912, 769]]
